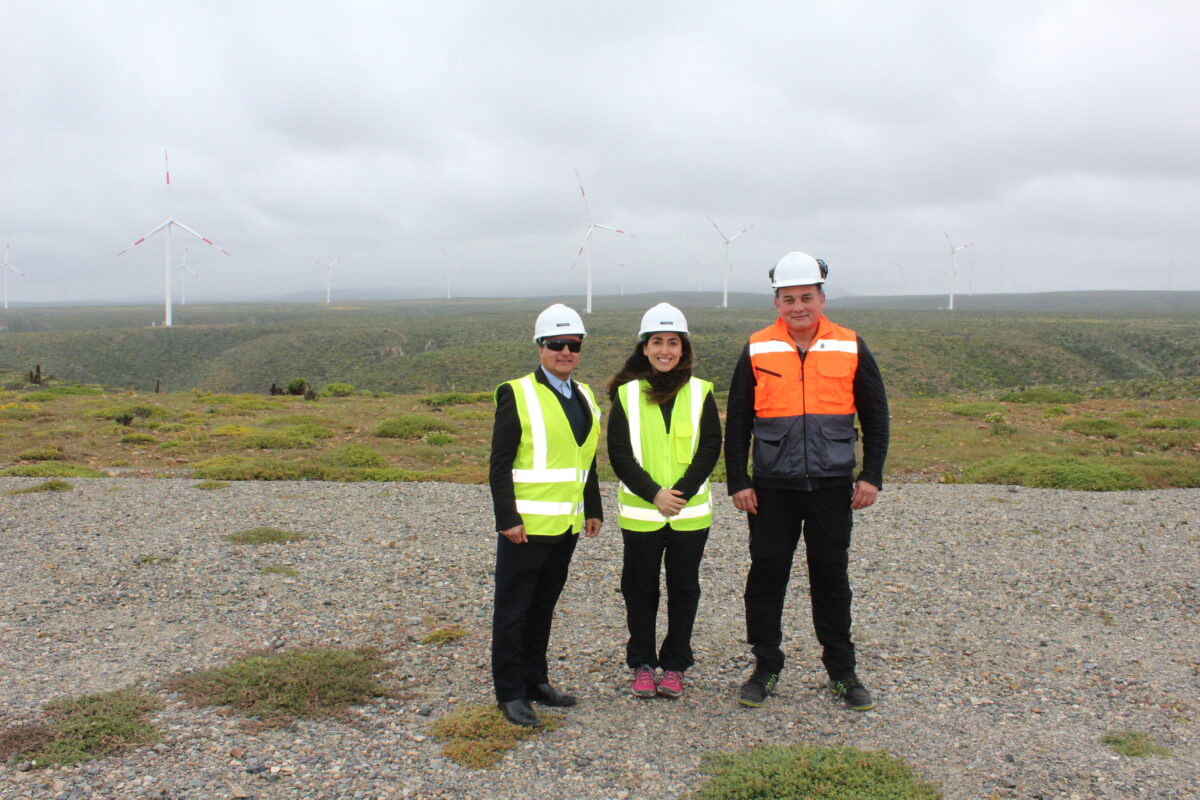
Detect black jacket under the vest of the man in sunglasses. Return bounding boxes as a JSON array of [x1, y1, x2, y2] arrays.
[[487, 368, 604, 531]]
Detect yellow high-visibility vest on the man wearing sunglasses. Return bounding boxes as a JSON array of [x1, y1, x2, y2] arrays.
[[496, 373, 600, 536]]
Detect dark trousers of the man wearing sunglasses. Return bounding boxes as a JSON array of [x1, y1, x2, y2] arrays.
[[492, 533, 578, 703]]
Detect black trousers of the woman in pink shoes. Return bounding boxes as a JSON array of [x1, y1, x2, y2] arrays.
[[620, 525, 708, 672]]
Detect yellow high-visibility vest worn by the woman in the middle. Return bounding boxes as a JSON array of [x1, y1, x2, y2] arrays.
[[617, 378, 713, 530]]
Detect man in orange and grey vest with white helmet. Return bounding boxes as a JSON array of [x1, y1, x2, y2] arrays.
[[725, 252, 888, 711]]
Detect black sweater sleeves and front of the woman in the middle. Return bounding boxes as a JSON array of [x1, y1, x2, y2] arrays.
[[608, 383, 721, 503]]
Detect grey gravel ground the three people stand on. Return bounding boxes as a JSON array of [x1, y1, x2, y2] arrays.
[[0, 479, 1200, 800]]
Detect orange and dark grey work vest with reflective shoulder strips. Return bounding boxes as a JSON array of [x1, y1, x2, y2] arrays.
[[749, 317, 858, 477]]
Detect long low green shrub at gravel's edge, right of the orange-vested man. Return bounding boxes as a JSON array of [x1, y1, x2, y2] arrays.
[[962, 453, 1146, 492]]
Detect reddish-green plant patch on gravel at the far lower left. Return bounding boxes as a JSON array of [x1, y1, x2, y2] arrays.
[[0, 688, 162, 766]]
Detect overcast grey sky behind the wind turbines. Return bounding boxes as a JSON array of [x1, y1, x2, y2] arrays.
[[0, 0, 1200, 302]]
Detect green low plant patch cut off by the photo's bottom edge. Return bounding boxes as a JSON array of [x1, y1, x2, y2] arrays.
[[690, 744, 943, 800]]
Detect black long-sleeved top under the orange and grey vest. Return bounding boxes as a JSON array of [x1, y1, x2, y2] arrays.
[[725, 336, 890, 494]]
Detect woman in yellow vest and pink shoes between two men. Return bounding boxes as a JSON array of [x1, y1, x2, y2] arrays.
[[608, 302, 721, 697]]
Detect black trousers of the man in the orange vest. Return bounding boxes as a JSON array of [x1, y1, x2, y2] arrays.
[[745, 486, 854, 676]]
